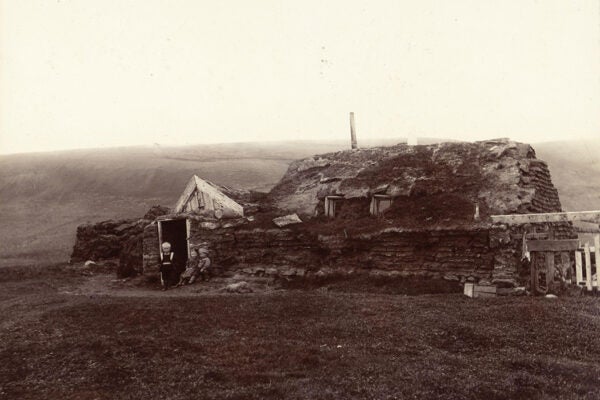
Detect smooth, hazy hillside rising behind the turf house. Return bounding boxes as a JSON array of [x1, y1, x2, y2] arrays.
[[0, 139, 600, 266]]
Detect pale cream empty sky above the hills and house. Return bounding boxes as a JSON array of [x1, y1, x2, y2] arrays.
[[0, 0, 600, 153]]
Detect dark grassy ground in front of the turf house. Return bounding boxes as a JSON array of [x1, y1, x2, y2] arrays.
[[0, 269, 600, 400]]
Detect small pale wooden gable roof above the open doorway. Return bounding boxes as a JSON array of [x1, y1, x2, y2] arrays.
[[174, 175, 244, 218]]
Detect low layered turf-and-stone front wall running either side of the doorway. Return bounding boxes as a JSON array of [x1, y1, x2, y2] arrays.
[[143, 220, 520, 280]]
